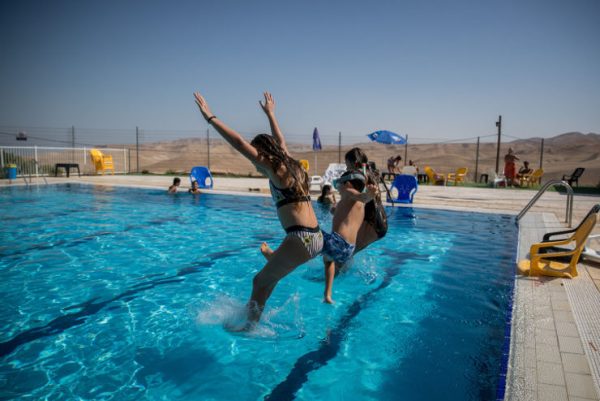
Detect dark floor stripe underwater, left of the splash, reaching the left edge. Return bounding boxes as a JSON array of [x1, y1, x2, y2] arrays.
[[0, 251, 240, 358]]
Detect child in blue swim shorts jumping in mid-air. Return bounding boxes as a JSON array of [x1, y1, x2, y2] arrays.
[[323, 148, 378, 303]]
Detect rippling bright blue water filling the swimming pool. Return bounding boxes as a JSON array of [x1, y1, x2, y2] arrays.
[[0, 185, 517, 401]]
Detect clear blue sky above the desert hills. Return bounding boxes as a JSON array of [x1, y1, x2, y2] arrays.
[[0, 0, 600, 143]]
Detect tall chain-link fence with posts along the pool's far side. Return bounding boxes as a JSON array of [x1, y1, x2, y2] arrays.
[[0, 126, 600, 186]]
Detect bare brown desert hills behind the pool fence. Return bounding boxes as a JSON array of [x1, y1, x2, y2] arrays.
[[129, 132, 600, 185]]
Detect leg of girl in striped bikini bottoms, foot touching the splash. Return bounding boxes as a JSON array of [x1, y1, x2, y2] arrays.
[[248, 236, 310, 323]]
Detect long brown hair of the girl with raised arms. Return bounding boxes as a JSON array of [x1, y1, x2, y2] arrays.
[[250, 134, 309, 195]]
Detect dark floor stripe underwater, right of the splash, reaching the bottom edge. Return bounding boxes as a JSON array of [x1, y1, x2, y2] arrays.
[[264, 249, 429, 401]]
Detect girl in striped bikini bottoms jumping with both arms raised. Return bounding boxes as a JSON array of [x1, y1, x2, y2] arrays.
[[194, 92, 323, 328]]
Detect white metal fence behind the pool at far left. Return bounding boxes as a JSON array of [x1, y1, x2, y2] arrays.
[[0, 146, 129, 176]]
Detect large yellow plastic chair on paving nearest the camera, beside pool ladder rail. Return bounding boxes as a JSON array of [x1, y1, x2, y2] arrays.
[[519, 205, 600, 278]]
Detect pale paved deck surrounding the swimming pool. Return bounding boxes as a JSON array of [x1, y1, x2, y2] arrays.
[[0, 175, 600, 401]]
